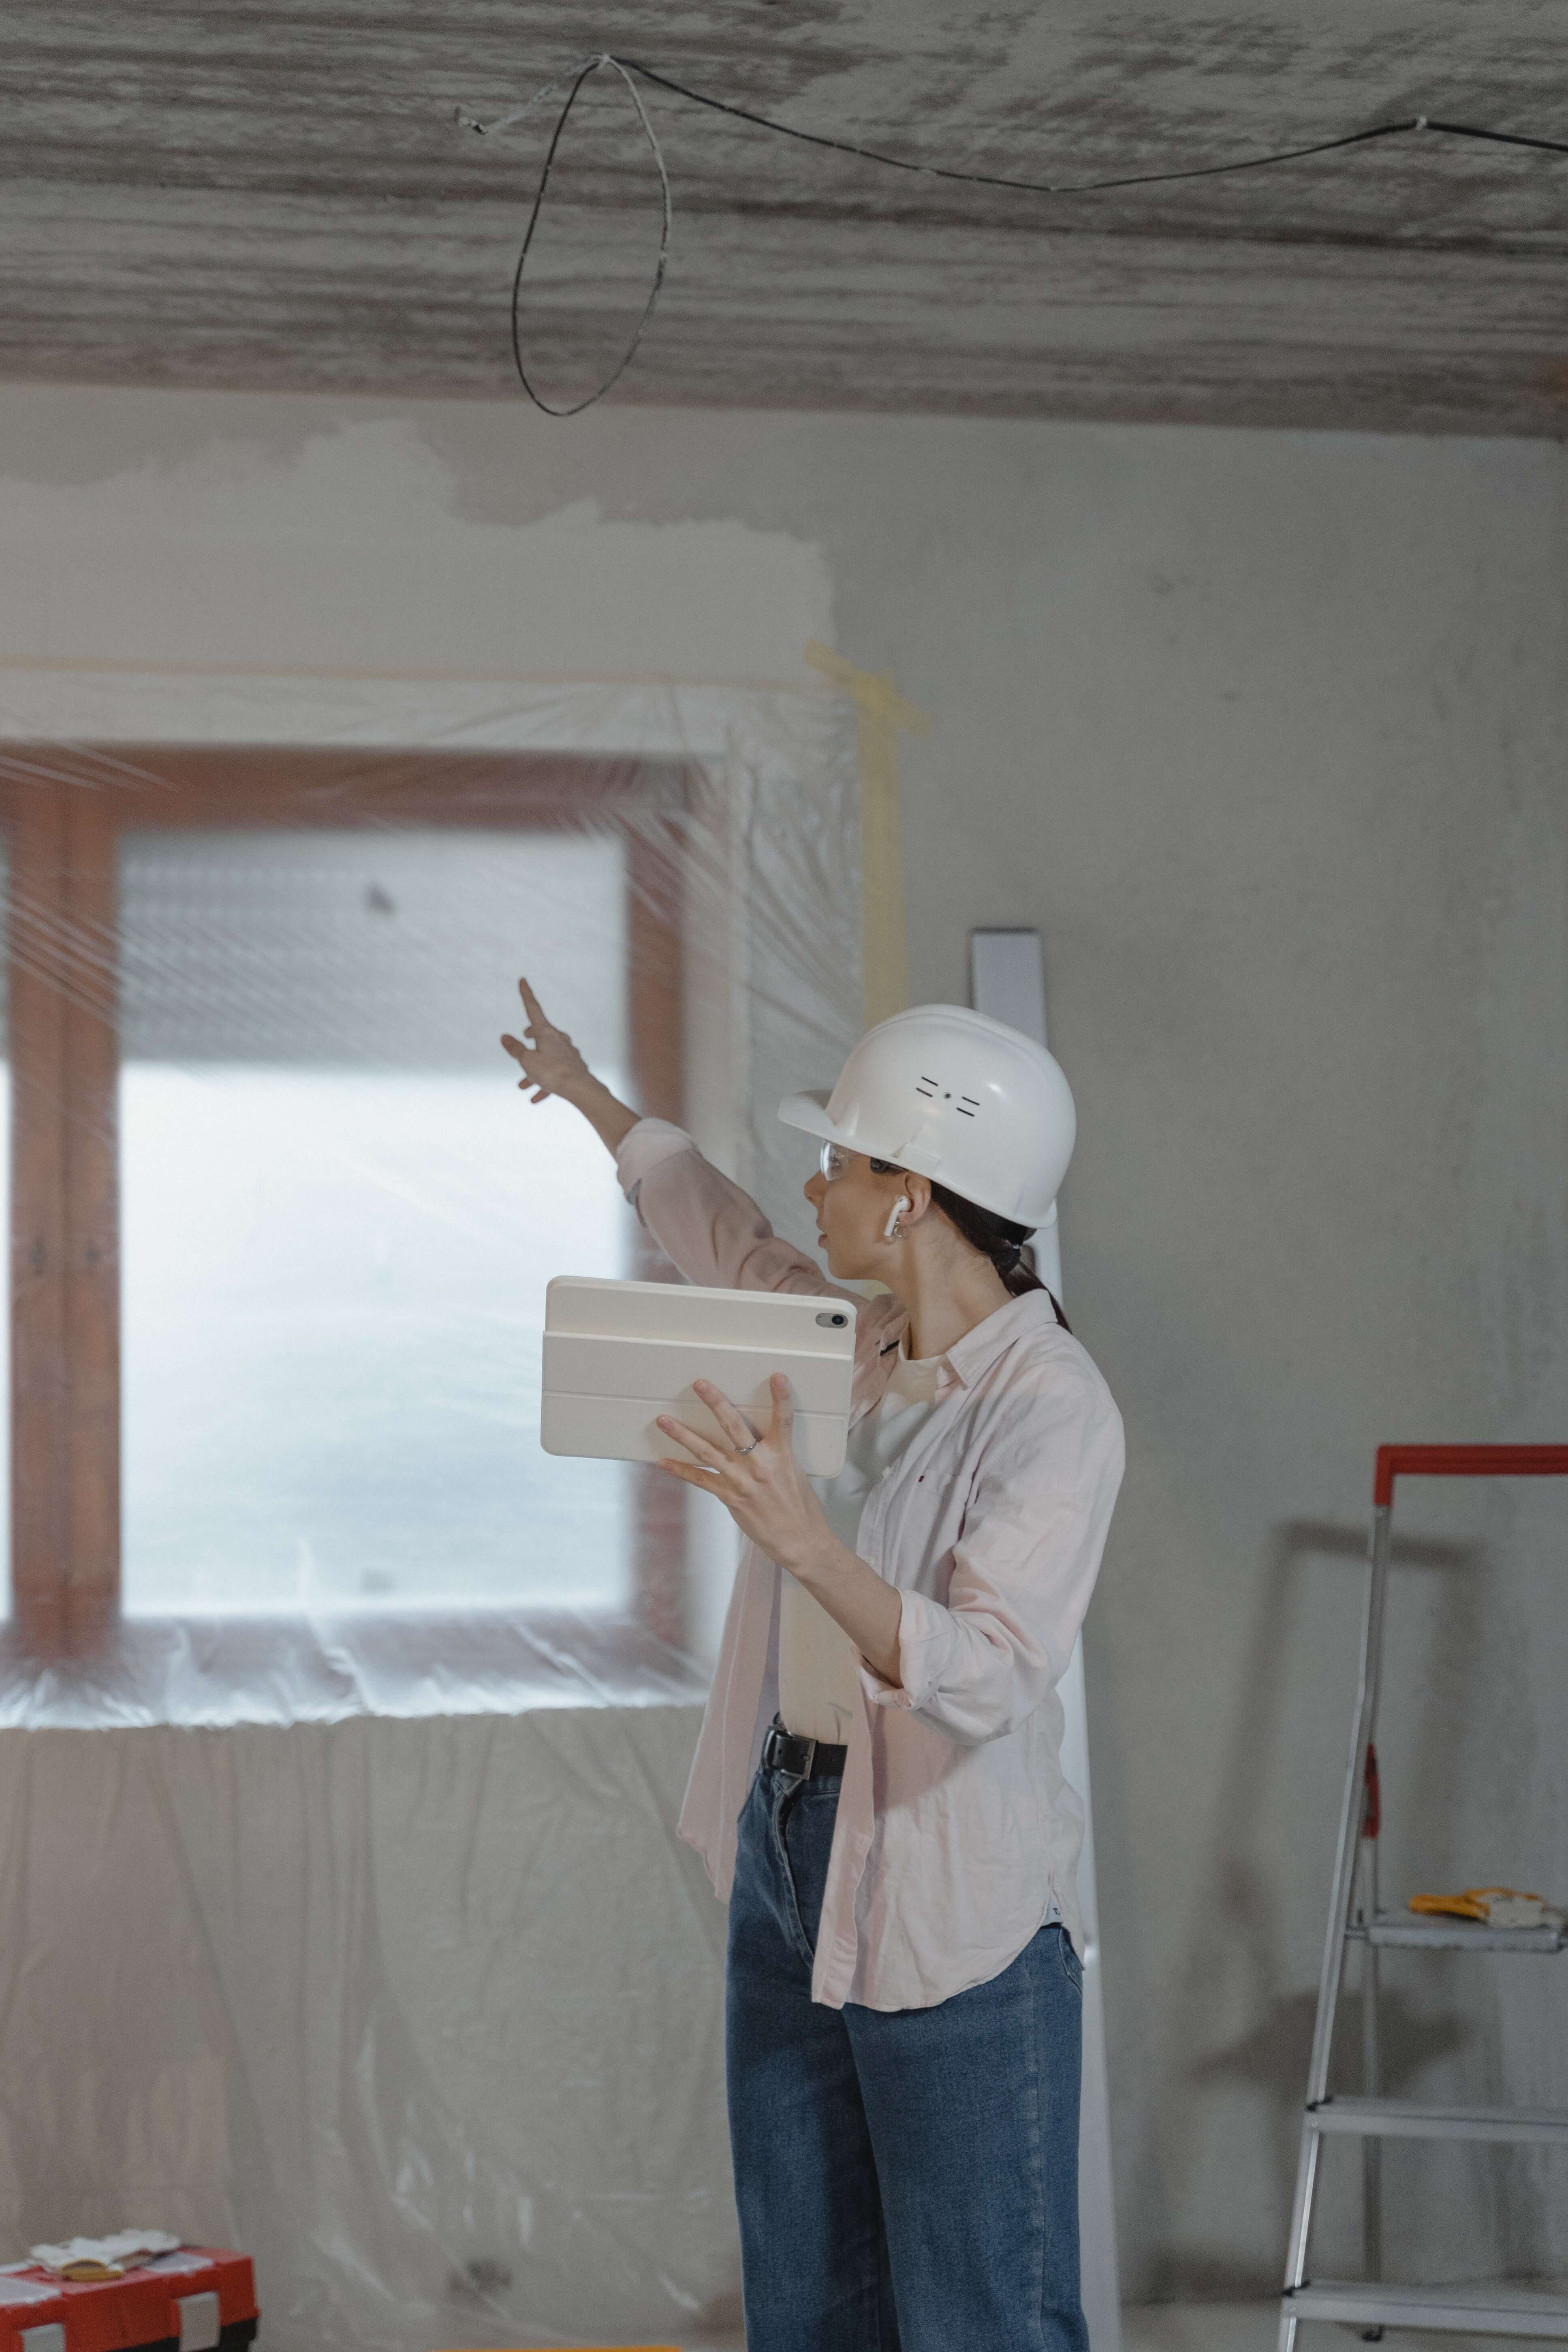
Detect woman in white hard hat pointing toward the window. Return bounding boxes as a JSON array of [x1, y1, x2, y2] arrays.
[[503, 981, 1122, 2352]]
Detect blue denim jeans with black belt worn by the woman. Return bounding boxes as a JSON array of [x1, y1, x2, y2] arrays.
[[726, 1771, 1088, 2352]]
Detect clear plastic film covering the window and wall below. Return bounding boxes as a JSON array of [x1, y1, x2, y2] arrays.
[[0, 682, 861, 2347]]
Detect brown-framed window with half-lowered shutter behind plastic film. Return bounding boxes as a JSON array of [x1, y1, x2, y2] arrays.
[[9, 753, 684, 1651]]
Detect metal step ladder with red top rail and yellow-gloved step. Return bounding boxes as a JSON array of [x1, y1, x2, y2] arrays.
[[1279, 1446, 1568, 2352]]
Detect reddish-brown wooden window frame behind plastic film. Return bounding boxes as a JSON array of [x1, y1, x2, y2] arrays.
[[0, 743, 691, 1658]]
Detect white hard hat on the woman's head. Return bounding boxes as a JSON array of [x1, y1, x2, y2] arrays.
[[778, 1004, 1079, 1230]]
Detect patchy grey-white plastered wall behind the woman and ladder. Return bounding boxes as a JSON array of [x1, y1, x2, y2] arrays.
[[0, 388, 1568, 2293]]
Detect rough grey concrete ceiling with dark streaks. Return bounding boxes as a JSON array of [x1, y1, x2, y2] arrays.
[[0, 0, 1568, 435]]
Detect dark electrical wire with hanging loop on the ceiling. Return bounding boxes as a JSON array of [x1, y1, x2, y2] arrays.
[[456, 49, 1568, 416]]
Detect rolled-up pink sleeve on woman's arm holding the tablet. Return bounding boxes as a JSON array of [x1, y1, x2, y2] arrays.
[[861, 1362, 1124, 1747]]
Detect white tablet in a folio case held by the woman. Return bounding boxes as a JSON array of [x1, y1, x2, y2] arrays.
[[538, 1275, 856, 1477]]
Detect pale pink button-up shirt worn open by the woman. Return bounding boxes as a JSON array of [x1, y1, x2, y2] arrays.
[[618, 1119, 1124, 2008]]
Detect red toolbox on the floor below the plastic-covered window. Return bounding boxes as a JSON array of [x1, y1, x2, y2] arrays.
[[0, 2246, 258, 2352]]
